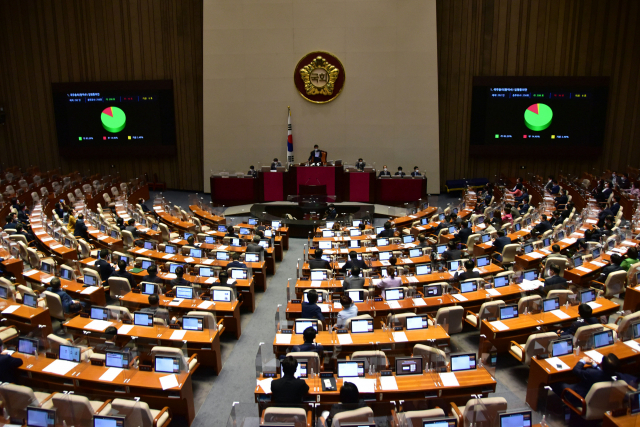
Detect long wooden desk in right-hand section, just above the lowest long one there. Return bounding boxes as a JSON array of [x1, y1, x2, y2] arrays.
[[480, 298, 620, 353]]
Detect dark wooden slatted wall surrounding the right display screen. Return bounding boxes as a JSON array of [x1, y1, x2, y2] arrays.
[[437, 0, 640, 191]]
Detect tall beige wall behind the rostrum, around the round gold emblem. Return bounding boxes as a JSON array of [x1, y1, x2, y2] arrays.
[[203, 0, 440, 193]]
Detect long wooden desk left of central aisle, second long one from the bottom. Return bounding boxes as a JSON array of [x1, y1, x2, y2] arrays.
[[64, 316, 224, 375]]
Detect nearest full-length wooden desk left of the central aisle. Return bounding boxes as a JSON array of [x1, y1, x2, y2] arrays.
[[13, 352, 195, 424]]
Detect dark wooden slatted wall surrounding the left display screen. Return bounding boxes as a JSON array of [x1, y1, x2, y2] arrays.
[[0, 0, 203, 191]]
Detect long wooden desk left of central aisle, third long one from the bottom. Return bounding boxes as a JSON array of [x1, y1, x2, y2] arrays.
[[120, 292, 242, 339]]
